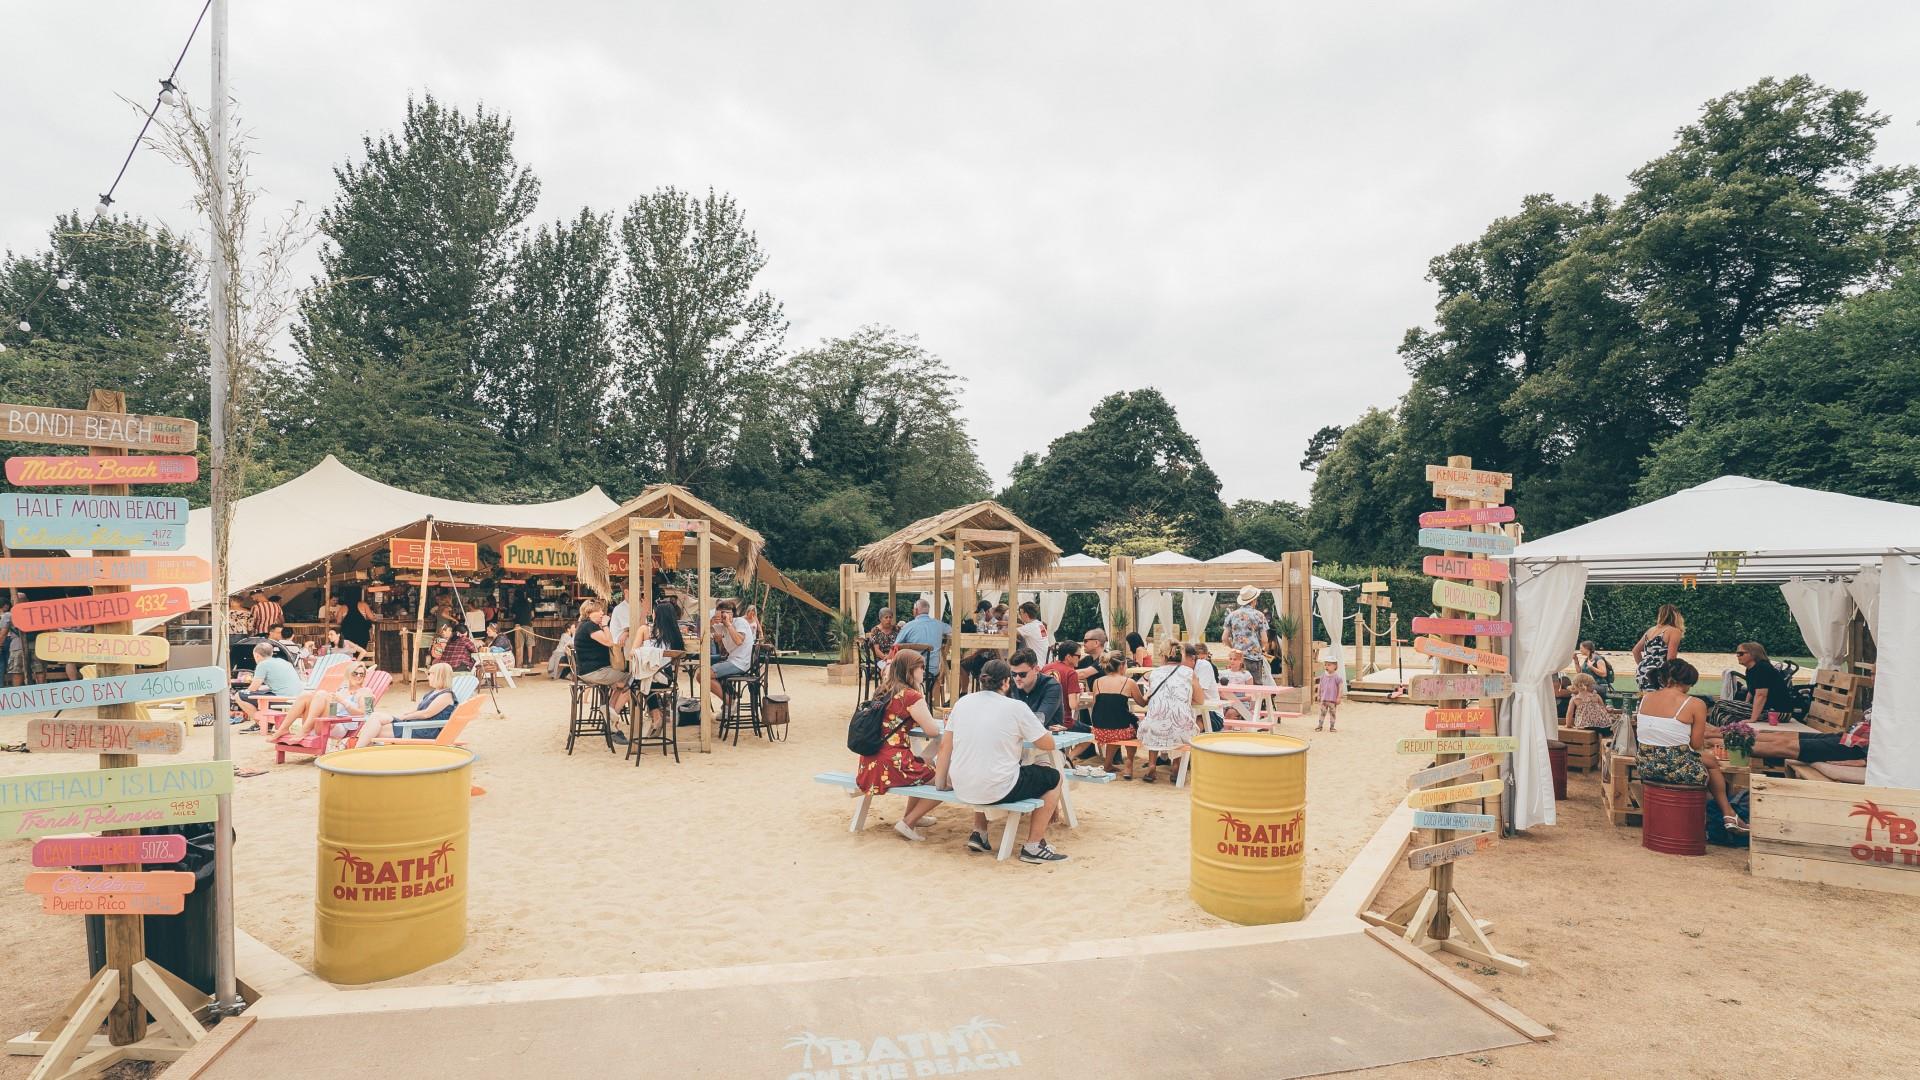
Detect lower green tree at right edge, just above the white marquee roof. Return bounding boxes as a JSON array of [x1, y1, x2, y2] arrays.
[[1638, 267, 1920, 503]]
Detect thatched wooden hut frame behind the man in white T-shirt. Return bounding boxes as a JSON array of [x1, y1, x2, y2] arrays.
[[856, 500, 1067, 701]]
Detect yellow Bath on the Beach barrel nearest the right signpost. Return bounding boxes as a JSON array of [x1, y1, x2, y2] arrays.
[[1187, 732, 1308, 926]]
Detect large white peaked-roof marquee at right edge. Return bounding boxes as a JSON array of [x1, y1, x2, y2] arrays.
[[1505, 477, 1920, 795]]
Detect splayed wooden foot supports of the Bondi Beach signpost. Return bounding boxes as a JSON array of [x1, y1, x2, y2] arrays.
[[6, 961, 207, 1080]]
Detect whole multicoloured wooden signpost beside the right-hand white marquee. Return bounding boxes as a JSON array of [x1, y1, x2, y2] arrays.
[[1363, 449, 1526, 974]]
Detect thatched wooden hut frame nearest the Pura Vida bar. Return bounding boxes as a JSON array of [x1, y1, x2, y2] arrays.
[[566, 484, 833, 753]]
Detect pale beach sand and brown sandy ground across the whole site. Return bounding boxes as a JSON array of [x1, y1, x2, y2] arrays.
[[0, 669, 1920, 1080]]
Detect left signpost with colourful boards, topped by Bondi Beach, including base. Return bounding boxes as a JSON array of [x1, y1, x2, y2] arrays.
[[0, 390, 216, 1080]]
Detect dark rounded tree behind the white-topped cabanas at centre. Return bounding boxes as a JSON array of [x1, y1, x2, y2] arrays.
[[1002, 390, 1227, 559]]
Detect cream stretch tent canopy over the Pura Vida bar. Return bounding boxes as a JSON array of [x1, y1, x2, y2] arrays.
[[108, 454, 614, 632]]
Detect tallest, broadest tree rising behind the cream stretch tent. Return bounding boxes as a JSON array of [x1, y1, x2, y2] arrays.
[[290, 94, 540, 496]]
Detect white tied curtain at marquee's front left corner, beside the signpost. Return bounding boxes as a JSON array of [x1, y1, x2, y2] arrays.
[[1505, 563, 1586, 828]]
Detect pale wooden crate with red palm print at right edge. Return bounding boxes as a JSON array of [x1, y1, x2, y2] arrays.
[[1749, 776, 1920, 896]]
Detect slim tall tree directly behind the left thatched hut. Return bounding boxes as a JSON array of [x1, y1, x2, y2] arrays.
[[616, 188, 787, 482]]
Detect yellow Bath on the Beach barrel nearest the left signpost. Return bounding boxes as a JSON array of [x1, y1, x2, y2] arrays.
[[313, 746, 474, 984]]
